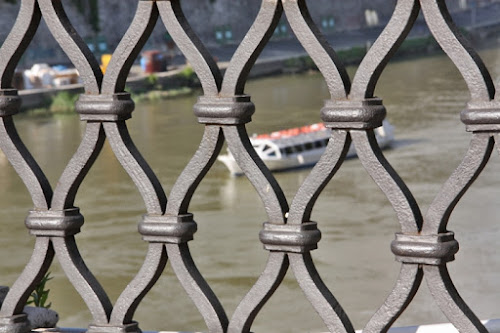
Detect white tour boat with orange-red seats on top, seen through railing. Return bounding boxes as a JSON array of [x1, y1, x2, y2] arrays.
[[217, 120, 394, 175]]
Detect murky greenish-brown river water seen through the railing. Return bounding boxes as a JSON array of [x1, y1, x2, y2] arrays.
[[0, 49, 500, 332]]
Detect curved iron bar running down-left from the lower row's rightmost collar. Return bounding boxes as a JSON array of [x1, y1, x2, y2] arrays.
[[363, 264, 424, 333]]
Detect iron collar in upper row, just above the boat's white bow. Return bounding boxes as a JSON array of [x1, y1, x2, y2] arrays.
[[194, 95, 255, 125]]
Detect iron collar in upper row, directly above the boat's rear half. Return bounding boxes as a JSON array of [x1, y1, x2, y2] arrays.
[[321, 98, 387, 130]]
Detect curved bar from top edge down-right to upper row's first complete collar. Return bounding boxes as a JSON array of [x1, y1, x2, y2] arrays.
[[38, 0, 102, 94]]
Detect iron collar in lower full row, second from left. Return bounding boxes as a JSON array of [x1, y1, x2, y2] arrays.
[[139, 214, 198, 244]]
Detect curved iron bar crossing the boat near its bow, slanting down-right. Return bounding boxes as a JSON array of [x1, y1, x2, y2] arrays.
[[223, 125, 288, 224]]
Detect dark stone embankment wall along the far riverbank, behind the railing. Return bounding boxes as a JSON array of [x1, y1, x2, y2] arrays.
[[0, 0, 480, 67]]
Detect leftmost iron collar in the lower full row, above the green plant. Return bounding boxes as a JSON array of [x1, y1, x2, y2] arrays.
[[25, 207, 84, 237]]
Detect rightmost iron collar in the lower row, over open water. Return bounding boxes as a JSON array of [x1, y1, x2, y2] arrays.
[[391, 231, 459, 265]]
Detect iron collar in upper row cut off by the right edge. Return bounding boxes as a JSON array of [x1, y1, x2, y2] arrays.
[[460, 101, 500, 132]]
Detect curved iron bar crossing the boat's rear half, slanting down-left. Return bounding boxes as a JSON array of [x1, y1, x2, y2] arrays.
[[288, 130, 351, 224]]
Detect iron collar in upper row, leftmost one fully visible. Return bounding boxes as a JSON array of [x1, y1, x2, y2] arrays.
[[76, 93, 135, 122]]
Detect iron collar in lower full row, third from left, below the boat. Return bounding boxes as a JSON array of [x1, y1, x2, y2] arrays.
[[259, 222, 321, 253]]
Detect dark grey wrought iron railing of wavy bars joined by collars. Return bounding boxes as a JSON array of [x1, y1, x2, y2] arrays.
[[0, 0, 500, 333]]
